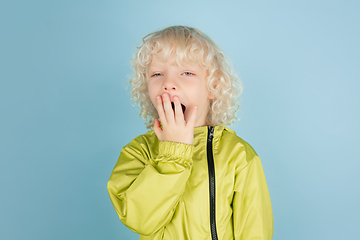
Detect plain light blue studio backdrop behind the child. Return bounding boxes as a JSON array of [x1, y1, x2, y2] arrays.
[[0, 0, 360, 240]]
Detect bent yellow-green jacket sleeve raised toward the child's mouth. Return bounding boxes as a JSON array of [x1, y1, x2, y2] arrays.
[[107, 140, 193, 235]]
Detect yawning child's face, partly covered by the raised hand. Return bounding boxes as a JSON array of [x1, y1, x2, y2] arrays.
[[147, 53, 212, 127]]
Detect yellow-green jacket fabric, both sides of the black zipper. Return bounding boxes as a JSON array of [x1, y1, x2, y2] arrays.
[[107, 125, 273, 240]]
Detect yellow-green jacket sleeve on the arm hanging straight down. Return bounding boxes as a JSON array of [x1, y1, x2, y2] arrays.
[[233, 152, 273, 240]]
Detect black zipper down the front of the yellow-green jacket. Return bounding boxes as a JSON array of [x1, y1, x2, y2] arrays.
[[206, 126, 218, 240]]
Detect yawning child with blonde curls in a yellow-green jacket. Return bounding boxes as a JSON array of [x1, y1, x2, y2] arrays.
[[108, 26, 273, 240]]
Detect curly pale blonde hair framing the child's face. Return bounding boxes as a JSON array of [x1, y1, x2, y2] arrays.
[[129, 26, 242, 129]]
